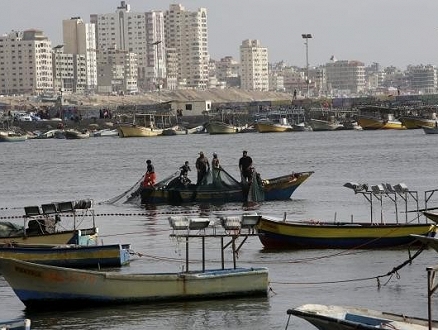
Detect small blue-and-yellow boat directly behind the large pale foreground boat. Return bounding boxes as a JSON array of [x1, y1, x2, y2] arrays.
[[0, 243, 131, 268]]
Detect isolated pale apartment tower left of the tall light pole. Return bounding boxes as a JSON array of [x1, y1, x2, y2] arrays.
[[240, 39, 269, 91]]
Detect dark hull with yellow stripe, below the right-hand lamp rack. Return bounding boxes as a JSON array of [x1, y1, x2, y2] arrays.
[[257, 217, 435, 249]]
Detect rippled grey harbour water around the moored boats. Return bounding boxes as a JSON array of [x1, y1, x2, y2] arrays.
[[0, 130, 438, 329]]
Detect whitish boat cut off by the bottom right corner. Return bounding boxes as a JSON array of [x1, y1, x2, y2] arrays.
[[286, 304, 438, 330]]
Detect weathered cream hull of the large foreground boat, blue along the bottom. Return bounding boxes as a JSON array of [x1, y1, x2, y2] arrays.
[[0, 259, 268, 310]]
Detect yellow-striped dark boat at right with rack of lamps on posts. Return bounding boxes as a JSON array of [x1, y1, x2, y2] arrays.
[[257, 182, 436, 249]]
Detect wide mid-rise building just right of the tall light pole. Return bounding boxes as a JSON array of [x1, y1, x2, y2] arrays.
[[326, 60, 365, 94]]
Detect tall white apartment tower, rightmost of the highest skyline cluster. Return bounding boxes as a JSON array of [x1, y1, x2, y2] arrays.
[[165, 4, 210, 89]]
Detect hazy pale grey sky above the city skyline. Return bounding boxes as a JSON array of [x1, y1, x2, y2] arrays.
[[0, 0, 438, 69]]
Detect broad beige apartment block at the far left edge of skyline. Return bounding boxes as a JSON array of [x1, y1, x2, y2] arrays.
[[0, 30, 53, 95]]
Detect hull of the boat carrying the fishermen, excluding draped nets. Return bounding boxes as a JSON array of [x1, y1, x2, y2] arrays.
[[141, 171, 313, 205]]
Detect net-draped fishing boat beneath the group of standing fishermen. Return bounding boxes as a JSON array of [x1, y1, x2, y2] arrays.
[[127, 168, 313, 205]]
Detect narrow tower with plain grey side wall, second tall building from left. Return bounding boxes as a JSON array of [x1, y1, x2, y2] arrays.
[[62, 17, 97, 92]]
